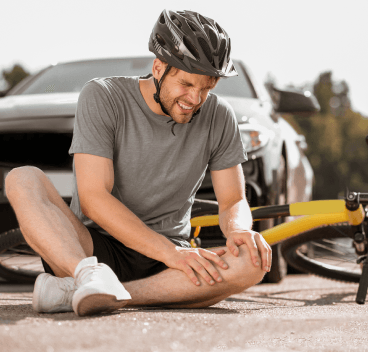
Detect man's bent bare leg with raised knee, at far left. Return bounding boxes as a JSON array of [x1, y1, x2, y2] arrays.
[[5, 166, 93, 277]]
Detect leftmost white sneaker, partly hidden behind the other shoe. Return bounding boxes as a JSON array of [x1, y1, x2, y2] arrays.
[[32, 273, 77, 313]]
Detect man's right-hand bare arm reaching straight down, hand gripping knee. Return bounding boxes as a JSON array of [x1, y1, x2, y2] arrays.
[[211, 164, 271, 271]]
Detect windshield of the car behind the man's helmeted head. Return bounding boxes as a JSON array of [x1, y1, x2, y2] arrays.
[[10, 57, 254, 98]]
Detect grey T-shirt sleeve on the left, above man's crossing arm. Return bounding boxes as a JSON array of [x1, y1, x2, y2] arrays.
[[69, 80, 117, 159]]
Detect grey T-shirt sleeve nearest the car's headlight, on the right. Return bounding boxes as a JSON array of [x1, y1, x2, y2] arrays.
[[208, 98, 248, 171]]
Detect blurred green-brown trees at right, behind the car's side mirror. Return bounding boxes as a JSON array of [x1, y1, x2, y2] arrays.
[[284, 72, 368, 199]]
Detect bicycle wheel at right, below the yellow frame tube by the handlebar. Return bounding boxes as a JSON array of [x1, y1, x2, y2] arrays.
[[281, 223, 362, 282]]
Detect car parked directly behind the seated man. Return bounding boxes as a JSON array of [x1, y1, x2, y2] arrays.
[[0, 57, 319, 282]]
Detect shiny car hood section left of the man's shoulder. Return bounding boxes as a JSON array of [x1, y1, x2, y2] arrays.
[[0, 92, 79, 119]]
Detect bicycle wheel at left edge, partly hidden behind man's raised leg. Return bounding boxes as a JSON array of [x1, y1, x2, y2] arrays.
[[0, 228, 44, 283]]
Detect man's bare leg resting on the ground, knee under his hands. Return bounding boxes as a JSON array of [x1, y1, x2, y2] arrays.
[[123, 245, 265, 308]]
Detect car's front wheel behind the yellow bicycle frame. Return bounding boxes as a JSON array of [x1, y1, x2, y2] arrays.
[[263, 155, 288, 283]]
